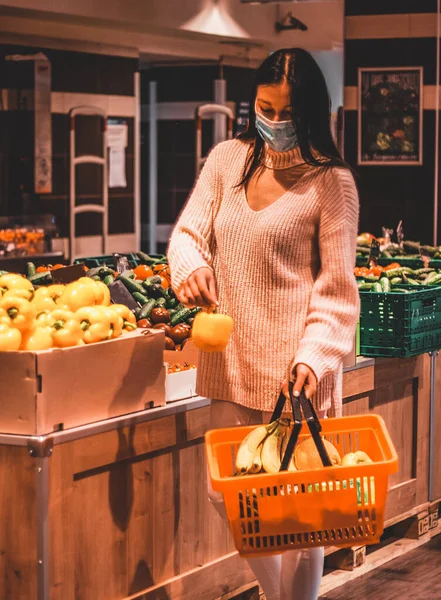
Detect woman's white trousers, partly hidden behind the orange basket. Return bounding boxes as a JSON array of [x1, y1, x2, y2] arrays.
[[208, 400, 324, 600]]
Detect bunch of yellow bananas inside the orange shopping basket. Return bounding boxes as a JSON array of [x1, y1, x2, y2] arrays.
[[236, 419, 296, 475]]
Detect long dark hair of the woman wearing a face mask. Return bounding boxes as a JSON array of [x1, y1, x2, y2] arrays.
[[238, 48, 352, 185]]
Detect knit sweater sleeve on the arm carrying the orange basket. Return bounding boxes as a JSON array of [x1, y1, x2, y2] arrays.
[[293, 169, 360, 381]]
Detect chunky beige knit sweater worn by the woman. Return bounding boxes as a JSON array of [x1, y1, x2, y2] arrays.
[[168, 140, 359, 415]]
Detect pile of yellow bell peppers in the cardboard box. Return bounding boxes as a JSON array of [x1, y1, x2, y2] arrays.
[[0, 273, 136, 351]]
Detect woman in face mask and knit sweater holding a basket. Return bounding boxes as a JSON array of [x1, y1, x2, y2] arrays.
[[169, 48, 359, 600]]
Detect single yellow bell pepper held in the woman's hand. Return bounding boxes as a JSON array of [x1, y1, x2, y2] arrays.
[[191, 311, 234, 352]]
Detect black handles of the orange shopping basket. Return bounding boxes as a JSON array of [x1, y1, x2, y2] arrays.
[[271, 381, 332, 471]]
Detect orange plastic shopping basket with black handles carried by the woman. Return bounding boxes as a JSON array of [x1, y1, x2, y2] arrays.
[[205, 386, 398, 557]]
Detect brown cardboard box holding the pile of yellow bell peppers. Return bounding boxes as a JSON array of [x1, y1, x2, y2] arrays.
[[0, 330, 165, 435]]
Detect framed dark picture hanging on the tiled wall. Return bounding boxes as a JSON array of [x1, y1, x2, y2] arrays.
[[358, 67, 423, 166]]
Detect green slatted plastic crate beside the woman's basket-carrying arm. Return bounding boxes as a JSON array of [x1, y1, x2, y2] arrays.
[[360, 286, 441, 358]]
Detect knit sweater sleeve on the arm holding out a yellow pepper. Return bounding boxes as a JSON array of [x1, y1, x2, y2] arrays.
[[167, 147, 221, 290]]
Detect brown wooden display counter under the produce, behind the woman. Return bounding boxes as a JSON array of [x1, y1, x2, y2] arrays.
[[0, 356, 434, 600]]
